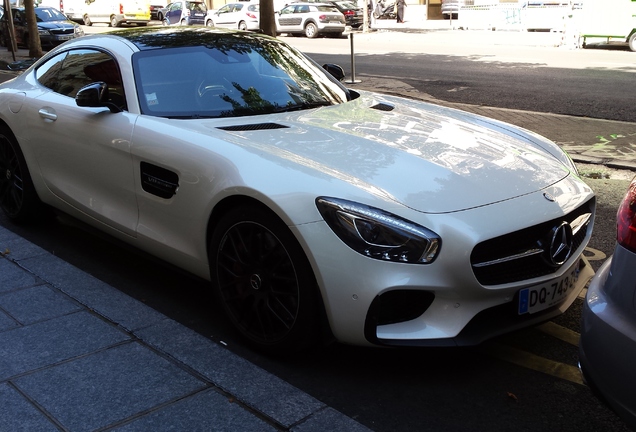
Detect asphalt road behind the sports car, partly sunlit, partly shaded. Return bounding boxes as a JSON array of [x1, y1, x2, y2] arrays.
[[283, 30, 636, 122]]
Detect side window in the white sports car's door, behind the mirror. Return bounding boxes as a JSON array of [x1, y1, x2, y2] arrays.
[[36, 49, 126, 110]]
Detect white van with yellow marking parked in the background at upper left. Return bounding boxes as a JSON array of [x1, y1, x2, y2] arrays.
[[83, 0, 150, 27]]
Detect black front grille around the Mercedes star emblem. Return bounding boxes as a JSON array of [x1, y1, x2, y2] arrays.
[[470, 199, 595, 285]]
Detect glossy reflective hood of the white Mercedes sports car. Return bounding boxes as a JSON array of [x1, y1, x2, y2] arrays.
[[202, 94, 570, 213]]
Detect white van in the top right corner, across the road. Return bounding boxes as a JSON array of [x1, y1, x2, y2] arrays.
[[577, 0, 636, 51]]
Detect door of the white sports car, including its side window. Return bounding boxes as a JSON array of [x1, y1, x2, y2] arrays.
[[23, 49, 138, 235]]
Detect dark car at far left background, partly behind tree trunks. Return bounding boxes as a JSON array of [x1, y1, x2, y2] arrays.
[[1, 7, 84, 48]]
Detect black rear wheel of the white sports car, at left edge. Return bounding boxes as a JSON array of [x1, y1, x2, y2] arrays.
[[0, 127, 42, 223]]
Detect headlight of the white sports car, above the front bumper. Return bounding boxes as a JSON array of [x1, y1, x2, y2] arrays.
[[316, 197, 442, 264]]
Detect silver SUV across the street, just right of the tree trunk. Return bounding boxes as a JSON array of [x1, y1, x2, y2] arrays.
[[275, 3, 346, 38]]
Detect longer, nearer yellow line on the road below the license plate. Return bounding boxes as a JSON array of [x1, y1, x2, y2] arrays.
[[484, 342, 584, 385]]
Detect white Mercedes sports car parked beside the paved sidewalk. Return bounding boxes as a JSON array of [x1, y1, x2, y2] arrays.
[[0, 27, 595, 352]]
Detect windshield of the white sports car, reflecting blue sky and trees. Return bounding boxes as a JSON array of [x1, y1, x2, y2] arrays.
[[133, 34, 348, 118]]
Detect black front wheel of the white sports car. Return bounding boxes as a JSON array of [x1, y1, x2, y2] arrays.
[[209, 205, 322, 355]]
